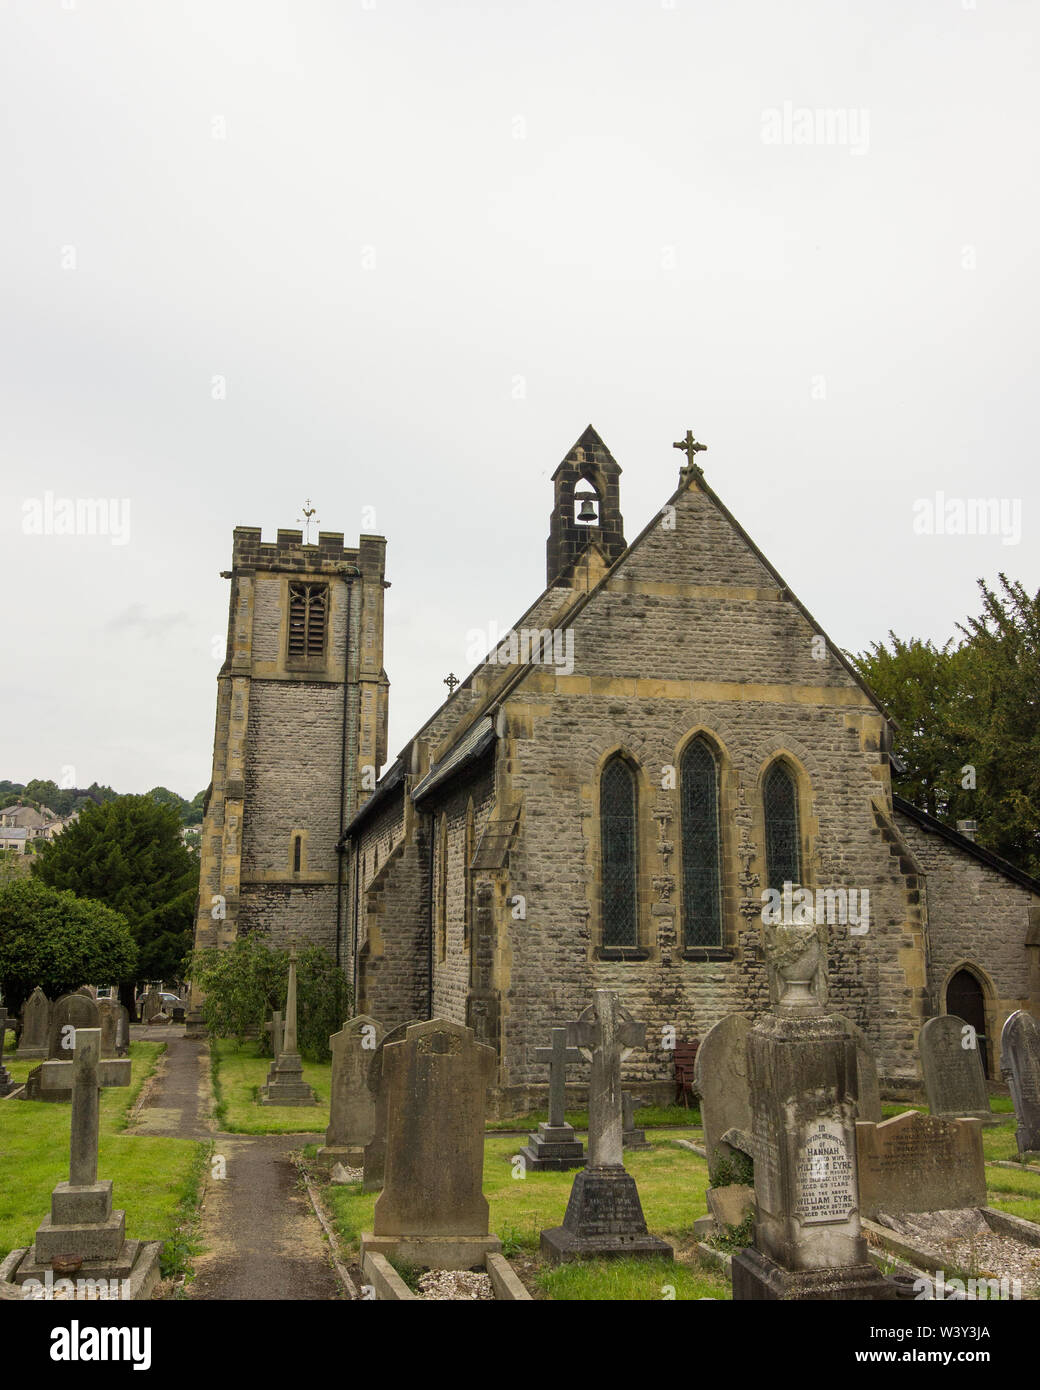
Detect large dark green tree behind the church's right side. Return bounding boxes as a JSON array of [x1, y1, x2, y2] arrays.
[[852, 574, 1040, 876]]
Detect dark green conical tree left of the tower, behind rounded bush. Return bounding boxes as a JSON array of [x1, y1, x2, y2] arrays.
[[32, 796, 199, 998]]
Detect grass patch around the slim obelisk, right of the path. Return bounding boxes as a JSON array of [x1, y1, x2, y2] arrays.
[[210, 1038, 332, 1134]]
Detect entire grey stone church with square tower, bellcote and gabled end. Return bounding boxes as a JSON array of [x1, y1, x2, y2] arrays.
[[189, 425, 1040, 1115]]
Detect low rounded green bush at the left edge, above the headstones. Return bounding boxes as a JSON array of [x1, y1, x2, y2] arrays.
[[0, 878, 138, 1013]]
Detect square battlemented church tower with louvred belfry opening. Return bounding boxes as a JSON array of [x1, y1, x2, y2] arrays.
[[188, 527, 389, 1029]]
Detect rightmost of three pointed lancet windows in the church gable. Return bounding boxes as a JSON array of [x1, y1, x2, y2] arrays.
[[680, 738, 722, 948]]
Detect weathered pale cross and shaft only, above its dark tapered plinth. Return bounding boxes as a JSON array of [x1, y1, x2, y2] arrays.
[[567, 990, 647, 1168]]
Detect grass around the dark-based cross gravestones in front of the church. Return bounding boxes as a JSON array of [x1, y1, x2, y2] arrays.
[[323, 1130, 730, 1300]]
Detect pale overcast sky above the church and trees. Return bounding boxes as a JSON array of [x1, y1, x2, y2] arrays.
[[0, 0, 1040, 796]]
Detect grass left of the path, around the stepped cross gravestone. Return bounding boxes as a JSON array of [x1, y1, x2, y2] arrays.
[[0, 1043, 207, 1266]]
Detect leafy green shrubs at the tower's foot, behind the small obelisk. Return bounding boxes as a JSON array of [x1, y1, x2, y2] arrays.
[[188, 933, 352, 1062]]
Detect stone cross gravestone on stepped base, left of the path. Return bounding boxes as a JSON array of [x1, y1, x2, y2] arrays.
[[1, 1028, 161, 1298]]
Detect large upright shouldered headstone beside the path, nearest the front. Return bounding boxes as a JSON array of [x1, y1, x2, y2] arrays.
[[361, 1019, 502, 1269]]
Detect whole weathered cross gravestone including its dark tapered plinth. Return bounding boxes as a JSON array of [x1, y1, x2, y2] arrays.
[[541, 990, 674, 1264]]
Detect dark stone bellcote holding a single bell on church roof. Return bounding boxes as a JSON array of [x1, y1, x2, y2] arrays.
[[545, 425, 624, 588]]
